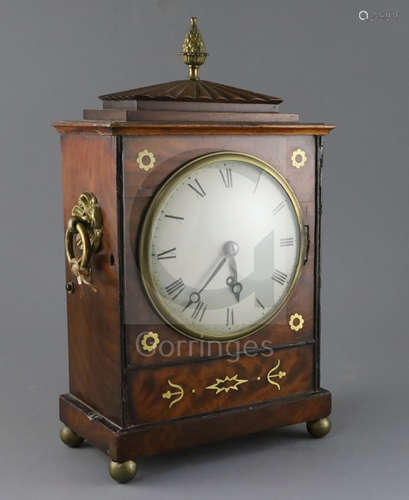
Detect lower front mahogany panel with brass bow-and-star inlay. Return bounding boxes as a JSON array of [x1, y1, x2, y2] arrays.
[[128, 345, 313, 423]]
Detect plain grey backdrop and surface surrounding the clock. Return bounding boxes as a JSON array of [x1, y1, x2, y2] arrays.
[[0, 0, 409, 499]]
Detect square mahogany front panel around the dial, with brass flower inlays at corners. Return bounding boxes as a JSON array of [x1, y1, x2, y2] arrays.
[[123, 135, 315, 366]]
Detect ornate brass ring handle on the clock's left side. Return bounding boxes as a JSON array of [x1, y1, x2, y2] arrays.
[[65, 193, 102, 292]]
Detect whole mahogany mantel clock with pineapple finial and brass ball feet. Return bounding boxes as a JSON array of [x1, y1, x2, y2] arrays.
[[54, 18, 334, 482]]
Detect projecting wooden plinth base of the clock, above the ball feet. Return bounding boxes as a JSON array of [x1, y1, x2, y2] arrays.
[[60, 389, 331, 462]]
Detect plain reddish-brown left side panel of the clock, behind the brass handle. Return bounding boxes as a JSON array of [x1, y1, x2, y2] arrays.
[[61, 134, 122, 423]]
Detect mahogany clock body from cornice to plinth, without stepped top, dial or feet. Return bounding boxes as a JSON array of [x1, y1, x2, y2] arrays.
[[56, 121, 333, 462]]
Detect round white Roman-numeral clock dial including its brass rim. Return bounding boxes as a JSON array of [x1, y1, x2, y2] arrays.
[[140, 153, 303, 340]]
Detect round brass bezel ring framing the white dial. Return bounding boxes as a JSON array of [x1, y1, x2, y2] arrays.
[[139, 151, 305, 342]]
